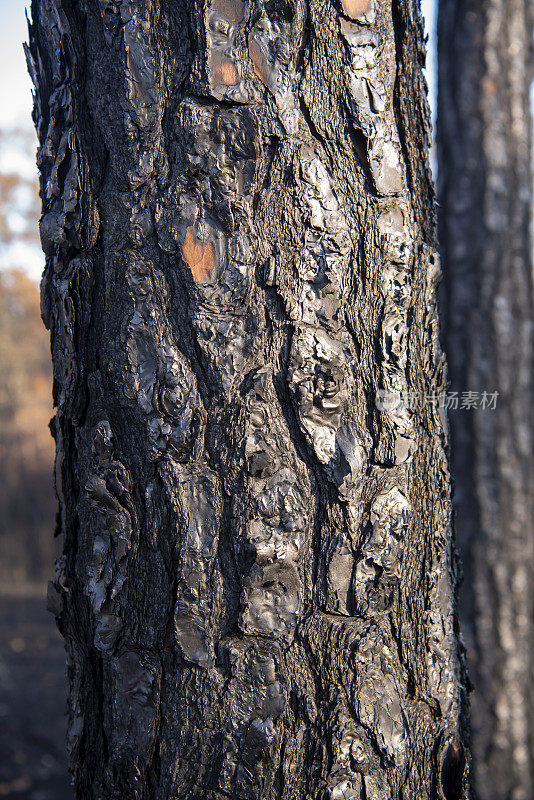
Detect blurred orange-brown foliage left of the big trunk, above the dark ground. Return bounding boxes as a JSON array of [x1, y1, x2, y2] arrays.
[[0, 270, 56, 586]]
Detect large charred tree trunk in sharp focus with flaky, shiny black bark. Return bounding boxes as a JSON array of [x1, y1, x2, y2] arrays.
[[29, 0, 467, 800]]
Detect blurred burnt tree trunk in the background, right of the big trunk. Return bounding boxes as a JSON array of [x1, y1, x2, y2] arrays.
[[438, 0, 534, 800]]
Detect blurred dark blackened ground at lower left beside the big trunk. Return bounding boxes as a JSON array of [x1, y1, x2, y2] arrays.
[[0, 591, 73, 800]]
